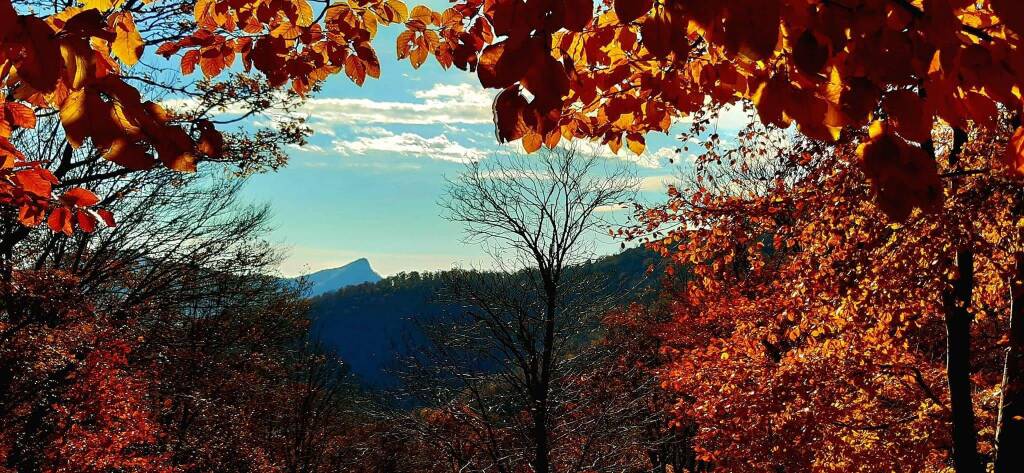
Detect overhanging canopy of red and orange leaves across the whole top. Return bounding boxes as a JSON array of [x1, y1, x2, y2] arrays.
[[6, 0, 1024, 231]]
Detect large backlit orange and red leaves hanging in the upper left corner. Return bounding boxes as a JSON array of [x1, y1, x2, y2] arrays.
[[0, 0, 219, 232]]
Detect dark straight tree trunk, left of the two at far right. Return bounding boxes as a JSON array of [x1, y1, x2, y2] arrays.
[[943, 250, 984, 473]]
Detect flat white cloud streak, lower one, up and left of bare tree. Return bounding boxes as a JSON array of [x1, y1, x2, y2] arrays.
[[332, 133, 486, 163]]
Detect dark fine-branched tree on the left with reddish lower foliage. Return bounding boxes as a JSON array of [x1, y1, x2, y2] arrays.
[[0, 135, 378, 472]]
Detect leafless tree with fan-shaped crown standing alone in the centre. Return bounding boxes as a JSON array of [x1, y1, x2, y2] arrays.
[[401, 148, 638, 473]]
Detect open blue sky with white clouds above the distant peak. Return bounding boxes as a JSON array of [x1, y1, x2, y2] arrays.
[[224, 0, 741, 276]]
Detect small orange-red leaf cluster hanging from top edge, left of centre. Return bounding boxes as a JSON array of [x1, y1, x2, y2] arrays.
[[157, 0, 409, 90]]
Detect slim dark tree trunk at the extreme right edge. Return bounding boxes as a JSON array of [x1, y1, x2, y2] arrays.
[[995, 253, 1024, 473]]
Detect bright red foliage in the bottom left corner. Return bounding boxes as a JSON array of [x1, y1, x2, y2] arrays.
[[0, 271, 173, 472]]
